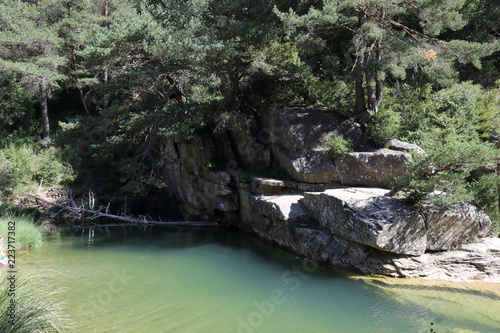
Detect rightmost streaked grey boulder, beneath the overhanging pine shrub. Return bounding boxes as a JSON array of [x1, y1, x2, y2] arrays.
[[422, 202, 491, 251]]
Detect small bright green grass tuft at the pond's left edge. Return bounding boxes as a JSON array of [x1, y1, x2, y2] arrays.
[[0, 213, 43, 250]]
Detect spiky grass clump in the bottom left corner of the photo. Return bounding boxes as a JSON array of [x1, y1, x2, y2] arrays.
[[0, 273, 70, 333]]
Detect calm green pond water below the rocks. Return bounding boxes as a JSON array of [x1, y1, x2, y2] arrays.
[[13, 228, 500, 333]]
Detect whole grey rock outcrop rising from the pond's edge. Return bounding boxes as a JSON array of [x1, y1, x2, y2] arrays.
[[164, 105, 500, 281]]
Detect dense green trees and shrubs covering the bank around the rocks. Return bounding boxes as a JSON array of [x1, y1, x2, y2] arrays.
[[0, 0, 500, 231]]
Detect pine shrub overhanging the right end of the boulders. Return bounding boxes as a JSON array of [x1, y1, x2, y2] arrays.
[[396, 140, 500, 203]]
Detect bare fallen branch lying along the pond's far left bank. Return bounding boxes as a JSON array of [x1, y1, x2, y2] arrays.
[[26, 193, 219, 227]]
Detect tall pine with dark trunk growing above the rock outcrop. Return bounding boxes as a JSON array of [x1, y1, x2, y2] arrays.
[[275, 0, 499, 123]]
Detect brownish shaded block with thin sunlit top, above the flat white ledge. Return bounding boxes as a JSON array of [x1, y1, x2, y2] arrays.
[[335, 148, 411, 188]]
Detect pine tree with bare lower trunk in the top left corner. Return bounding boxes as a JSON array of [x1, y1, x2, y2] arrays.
[[0, 0, 67, 140]]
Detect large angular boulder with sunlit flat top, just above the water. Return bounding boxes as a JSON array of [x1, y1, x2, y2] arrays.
[[302, 188, 427, 255]]
